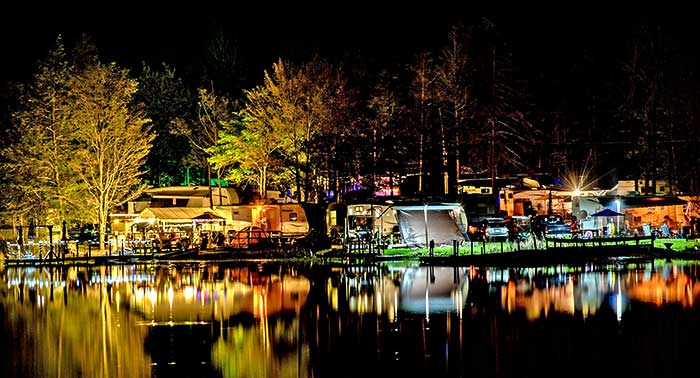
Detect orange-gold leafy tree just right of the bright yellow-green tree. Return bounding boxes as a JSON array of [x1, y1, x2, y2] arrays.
[[245, 59, 356, 201]]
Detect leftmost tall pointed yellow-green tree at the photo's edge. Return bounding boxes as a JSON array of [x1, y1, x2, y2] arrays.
[[2, 36, 87, 224]]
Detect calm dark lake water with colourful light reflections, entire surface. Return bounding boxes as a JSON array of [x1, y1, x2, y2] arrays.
[[0, 260, 700, 377]]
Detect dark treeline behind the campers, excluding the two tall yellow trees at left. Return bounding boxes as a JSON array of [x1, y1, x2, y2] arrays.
[[0, 16, 700, 227]]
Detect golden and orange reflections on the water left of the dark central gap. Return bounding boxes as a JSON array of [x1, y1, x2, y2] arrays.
[[0, 265, 311, 377]]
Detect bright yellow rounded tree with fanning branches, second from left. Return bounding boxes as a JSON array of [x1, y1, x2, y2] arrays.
[[69, 63, 154, 251]]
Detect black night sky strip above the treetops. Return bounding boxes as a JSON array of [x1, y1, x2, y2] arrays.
[[0, 11, 699, 100]]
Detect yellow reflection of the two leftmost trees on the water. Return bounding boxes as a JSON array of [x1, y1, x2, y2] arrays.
[[0, 274, 150, 377]]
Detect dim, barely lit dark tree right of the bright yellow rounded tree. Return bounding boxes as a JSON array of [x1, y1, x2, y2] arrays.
[[136, 64, 195, 186]]
